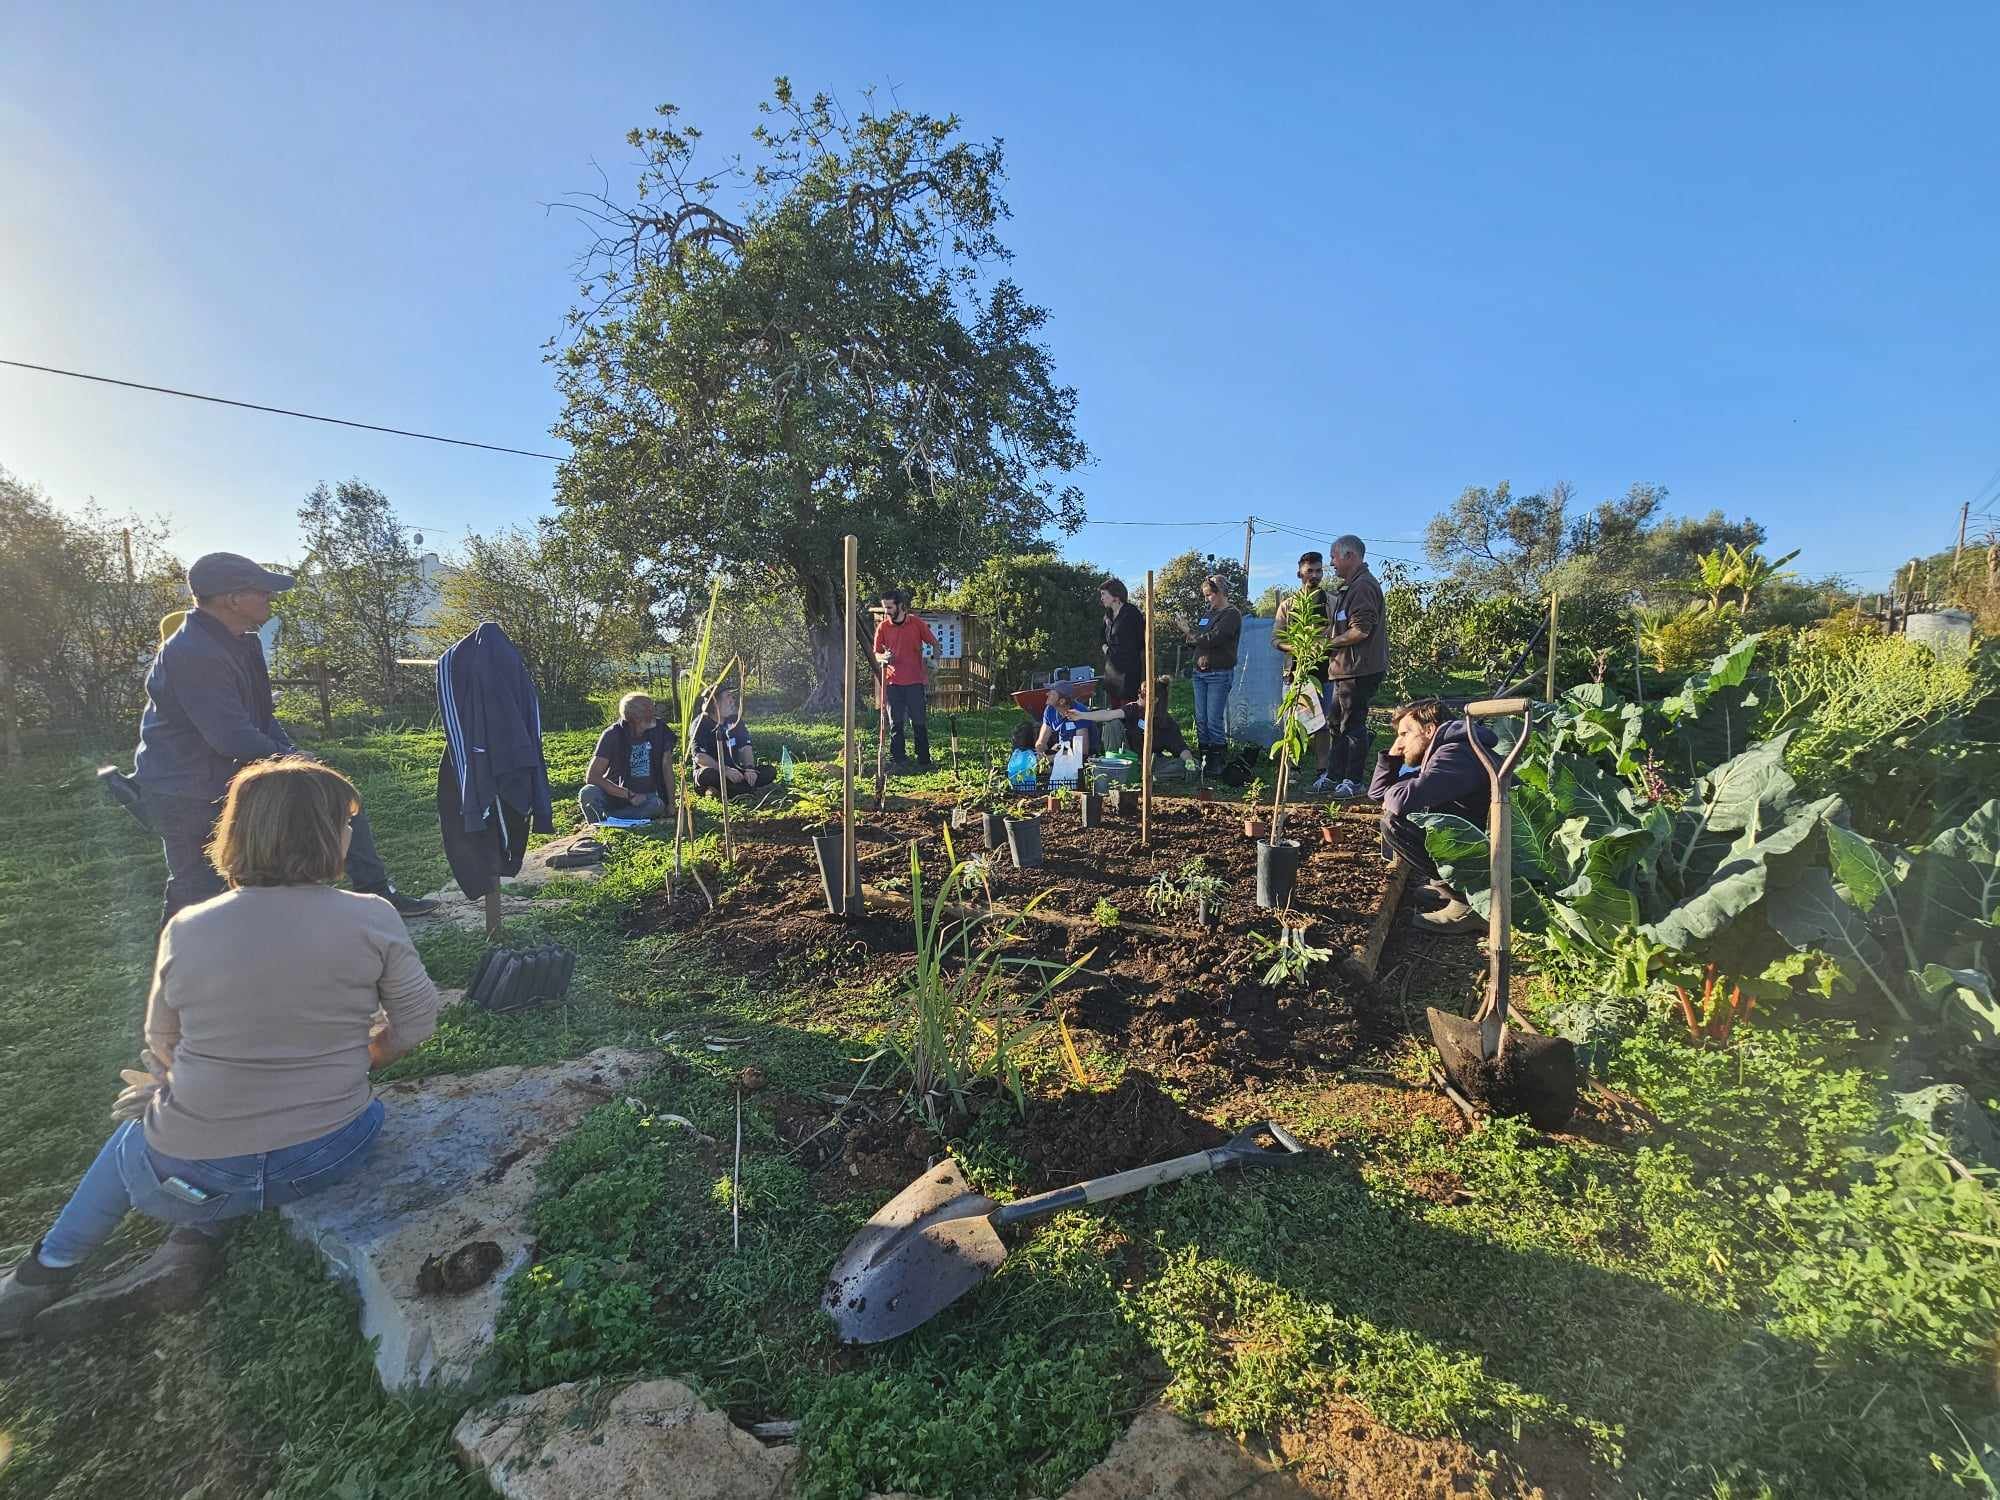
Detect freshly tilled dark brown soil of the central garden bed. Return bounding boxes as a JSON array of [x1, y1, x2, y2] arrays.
[[634, 800, 1400, 1100]]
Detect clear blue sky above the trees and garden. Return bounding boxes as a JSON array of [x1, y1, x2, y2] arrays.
[[0, 4, 2000, 588]]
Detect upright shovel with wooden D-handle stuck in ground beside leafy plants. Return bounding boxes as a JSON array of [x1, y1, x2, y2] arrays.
[[1426, 698, 1576, 1130]]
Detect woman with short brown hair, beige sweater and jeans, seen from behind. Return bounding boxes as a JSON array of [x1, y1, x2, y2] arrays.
[[0, 756, 438, 1340]]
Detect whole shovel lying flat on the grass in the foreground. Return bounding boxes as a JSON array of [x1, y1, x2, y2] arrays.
[[820, 1120, 1306, 1344]]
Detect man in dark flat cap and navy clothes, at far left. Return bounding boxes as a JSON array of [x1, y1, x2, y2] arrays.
[[132, 552, 432, 924]]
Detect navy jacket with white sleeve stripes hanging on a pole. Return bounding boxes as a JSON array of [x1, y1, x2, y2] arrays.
[[438, 622, 554, 896]]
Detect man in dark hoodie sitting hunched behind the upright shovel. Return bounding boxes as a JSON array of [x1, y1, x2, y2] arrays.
[[1368, 698, 1496, 932]]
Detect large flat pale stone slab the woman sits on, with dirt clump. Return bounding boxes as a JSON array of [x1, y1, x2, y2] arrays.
[[280, 1048, 660, 1390]]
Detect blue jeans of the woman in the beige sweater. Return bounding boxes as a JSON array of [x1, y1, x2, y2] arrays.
[[40, 1100, 382, 1270]]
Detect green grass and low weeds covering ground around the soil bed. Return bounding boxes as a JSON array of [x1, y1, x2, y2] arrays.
[[0, 710, 2000, 1498]]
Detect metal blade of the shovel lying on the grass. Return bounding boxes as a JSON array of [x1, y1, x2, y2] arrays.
[[820, 1160, 1006, 1344]]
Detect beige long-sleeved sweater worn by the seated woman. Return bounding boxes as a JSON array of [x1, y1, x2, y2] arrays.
[[146, 886, 438, 1160]]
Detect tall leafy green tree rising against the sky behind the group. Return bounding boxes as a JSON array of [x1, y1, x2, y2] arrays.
[[550, 78, 1088, 706]]
